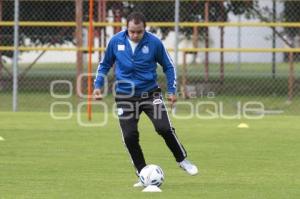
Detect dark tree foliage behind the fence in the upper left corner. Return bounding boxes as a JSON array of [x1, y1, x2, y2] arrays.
[[0, 1, 75, 57]]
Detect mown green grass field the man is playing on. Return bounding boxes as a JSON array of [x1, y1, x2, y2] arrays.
[[0, 112, 300, 199]]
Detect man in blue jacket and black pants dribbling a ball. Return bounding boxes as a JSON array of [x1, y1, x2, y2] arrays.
[[94, 12, 198, 187]]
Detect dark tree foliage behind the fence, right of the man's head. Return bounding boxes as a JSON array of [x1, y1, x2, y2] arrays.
[[125, 0, 254, 39]]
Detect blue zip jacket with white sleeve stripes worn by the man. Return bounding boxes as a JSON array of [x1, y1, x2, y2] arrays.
[[94, 30, 176, 96]]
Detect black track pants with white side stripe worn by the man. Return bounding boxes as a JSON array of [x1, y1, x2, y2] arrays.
[[116, 92, 186, 172]]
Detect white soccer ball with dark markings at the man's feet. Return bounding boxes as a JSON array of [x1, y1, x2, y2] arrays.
[[140, 164, 165, 187]]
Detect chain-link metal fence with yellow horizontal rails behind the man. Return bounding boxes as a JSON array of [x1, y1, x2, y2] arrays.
[[0, 0, 300, 114]]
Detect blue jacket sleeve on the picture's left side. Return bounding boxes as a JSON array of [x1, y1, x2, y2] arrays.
[[94, 40, 115, 89]]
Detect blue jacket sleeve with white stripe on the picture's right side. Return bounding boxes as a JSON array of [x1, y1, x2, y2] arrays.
[[157, 41, 176, 94]]
